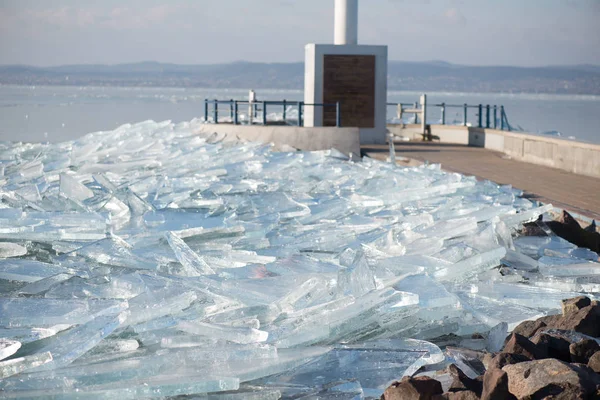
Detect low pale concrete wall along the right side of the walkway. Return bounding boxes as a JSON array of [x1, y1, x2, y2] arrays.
[[388, 124, 600, 178]]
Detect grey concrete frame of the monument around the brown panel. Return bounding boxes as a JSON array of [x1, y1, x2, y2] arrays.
[[304, 44, 388, 144]]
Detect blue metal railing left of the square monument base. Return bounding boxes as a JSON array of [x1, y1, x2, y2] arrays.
[[204, 99, 342, 128]]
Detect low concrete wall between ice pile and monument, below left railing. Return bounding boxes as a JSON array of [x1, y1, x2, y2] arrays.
[[198, 124, 360, 159]]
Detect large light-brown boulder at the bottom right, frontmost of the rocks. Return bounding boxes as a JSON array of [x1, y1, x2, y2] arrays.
[[502, 358, 600, 399]]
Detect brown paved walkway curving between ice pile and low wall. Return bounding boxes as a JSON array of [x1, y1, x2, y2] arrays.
[[361, 142, 600, 220]]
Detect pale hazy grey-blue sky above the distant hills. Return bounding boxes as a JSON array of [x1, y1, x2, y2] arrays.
[[0, 0, 600, 66]]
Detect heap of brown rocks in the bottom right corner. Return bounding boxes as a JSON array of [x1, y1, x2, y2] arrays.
[[381, 296, 600, 400]]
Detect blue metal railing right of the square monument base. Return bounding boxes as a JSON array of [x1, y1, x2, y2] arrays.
[[387, 103, 512, 131]]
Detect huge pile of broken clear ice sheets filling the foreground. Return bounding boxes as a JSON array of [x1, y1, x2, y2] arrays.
[[0, 121, 600, 399]]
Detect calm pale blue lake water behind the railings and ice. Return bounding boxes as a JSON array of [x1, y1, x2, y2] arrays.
[[0, 85, 600, 143]]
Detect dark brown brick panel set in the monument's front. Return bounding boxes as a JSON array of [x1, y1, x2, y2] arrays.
[[323, 55, 375, 128]]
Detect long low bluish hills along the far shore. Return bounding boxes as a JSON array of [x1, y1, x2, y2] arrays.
[[0, 61, 600, 95]]
